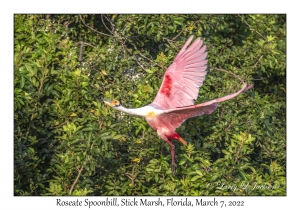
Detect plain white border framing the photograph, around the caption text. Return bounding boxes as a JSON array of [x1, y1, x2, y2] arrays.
[[0, 0, 300, 210]]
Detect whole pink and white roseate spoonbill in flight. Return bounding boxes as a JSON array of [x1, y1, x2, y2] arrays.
[[104, 36, 252, 174]]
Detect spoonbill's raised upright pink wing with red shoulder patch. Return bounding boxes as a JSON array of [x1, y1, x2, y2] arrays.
[[151, 36, 207, 110]]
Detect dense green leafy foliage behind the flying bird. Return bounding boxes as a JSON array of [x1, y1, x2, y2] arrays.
[[14, 15, 286, 196]]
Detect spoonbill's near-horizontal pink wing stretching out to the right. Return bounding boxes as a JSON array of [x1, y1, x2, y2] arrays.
[[161, 84, 253, 128]]
